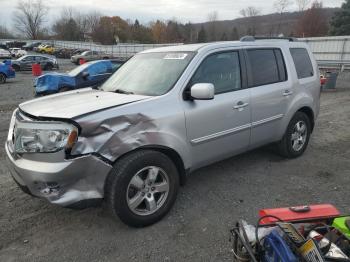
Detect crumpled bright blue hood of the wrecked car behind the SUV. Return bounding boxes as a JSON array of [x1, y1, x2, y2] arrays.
[[34, 72, 75, 94]]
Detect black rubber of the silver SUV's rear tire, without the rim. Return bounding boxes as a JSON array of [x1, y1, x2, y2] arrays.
[[277, 111, 311, 158]]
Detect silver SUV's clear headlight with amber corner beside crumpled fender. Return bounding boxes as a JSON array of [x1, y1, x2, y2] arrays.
[[14, 121, 78, 153]]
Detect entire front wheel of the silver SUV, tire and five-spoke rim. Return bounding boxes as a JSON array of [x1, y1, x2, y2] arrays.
[[105, 150, 179, 227]]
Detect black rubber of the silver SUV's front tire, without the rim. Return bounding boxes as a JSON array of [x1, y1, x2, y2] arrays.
[[105, 150, 179, 227]]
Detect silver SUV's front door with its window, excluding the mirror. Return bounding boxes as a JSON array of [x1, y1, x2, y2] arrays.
[[184, 50, 251, 168]]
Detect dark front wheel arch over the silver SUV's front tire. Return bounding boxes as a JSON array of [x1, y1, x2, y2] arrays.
[[114, 145, 188, 186]]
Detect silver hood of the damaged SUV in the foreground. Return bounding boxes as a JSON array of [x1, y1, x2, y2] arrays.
[[19, 88, 149, 119]]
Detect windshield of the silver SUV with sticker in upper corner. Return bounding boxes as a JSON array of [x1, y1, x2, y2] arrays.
[[101, 52, 194, 96]]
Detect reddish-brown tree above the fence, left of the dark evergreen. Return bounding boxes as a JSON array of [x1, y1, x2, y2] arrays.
[[296, 0, 328, 37]]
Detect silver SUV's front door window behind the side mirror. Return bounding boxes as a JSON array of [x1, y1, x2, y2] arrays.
[[190, 51, 241, 94]]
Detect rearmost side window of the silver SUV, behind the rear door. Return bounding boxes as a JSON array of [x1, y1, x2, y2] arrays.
[[290, 48, 314, 79]]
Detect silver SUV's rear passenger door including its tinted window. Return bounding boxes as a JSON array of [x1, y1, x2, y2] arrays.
[[245, 48, 295, 148]]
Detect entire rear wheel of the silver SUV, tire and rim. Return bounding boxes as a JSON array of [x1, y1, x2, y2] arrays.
[[277, 111, 311, 158]]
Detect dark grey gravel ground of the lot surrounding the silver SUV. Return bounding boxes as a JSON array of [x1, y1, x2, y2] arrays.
[[0, 60, 350, 262]]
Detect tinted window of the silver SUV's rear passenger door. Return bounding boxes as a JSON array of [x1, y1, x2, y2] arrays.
[[247, 49, 287, 87]]
